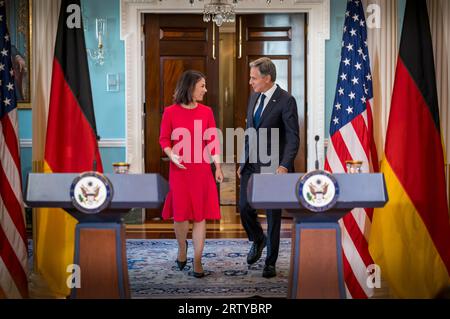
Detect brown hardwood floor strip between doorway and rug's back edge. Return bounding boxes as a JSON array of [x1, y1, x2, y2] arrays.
[[127, 206, 292, 239]]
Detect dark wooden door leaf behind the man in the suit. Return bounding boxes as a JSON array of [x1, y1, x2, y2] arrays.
[[234, 14, 307, 208]]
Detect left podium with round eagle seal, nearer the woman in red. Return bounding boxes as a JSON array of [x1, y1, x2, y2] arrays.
[[25, 172, 168, 299]]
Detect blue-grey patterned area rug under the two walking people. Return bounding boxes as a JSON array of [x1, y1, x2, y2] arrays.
[[127, 239, 291, 299]]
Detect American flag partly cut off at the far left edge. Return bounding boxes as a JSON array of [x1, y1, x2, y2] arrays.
[[0, 1, 28, 298]]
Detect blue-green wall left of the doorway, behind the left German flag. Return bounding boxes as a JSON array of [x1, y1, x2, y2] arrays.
[[19, 0, 126, 180]]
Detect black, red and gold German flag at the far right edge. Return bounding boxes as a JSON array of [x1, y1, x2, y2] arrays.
[[369, 0, 450, 298]]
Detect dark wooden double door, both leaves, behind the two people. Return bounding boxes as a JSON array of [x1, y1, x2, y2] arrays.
[[144, 14, 307, 218]]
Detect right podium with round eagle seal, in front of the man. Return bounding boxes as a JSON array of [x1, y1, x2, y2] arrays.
[[247, 171, 388, 299]]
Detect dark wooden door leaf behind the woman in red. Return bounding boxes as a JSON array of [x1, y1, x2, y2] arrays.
[[144, 14, 219, 219]]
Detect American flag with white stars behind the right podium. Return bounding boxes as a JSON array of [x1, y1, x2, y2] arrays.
[[325, 0, 378, 298]]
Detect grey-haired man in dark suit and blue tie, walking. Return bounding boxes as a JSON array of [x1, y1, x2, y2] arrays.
[[237, 58, 300, 278]]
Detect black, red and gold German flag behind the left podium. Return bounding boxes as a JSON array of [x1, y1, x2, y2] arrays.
[[36, 0, 103, 297]]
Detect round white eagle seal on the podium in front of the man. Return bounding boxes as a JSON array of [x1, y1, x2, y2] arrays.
[[296, 170, 339, 213]]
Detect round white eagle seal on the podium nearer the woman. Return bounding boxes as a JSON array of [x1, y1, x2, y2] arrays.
[[70, 172, 113, 214]]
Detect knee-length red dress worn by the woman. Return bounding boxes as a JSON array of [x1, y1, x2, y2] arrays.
[[159, 104, 220, 222]]
